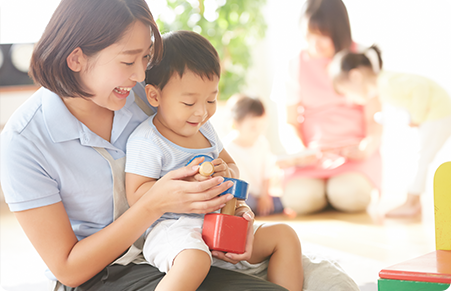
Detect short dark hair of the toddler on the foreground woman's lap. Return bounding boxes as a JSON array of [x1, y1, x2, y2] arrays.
[[146, 30, 221, 90]]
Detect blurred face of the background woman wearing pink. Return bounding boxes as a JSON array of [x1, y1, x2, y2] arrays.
[[302, 22, 335, 58]]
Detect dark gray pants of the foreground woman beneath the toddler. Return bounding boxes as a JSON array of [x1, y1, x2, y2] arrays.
[[64, 264, 286, 291]]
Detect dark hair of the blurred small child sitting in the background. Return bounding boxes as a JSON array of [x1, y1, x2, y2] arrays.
[[230, 94, 265, 122]]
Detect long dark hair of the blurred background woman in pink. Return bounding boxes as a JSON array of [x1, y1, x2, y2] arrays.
[[302, 0, 352, 53]]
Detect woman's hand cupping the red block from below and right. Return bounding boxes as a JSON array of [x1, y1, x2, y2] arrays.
[[211, 200, 254, 264]]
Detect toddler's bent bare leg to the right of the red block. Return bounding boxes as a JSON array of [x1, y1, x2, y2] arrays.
[[249, 224, 304, 291]]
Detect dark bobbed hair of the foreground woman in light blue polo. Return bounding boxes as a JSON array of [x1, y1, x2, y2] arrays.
[[30, 0, 162, 97]]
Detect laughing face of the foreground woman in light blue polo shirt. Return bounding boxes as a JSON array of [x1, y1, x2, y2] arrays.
[[80, 21, 152, 111]]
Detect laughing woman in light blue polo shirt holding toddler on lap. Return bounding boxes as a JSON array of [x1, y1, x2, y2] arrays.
[[1, 0, 283, 290]]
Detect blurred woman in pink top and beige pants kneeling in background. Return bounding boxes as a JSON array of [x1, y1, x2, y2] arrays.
[[272, 0, 382, 214]]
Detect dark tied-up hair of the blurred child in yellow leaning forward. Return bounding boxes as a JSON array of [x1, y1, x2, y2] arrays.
[[329, 45, 383, 80]]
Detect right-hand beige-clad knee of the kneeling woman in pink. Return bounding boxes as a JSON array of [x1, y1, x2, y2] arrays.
[[326, 173, 373, 212]]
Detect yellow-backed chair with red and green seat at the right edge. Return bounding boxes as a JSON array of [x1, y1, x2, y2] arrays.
[[378, 162, 451, 291]]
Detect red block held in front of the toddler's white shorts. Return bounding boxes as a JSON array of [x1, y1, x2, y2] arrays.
[[202, 213, 248, 254]]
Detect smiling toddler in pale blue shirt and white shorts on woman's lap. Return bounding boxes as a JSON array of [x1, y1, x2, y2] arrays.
[[126, 31, 303, 290]]
